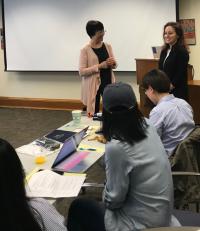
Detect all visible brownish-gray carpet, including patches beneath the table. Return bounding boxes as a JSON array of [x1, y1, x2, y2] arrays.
[[0, 108, 105, 216]]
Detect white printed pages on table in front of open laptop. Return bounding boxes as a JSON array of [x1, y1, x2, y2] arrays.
[[26, 170, 86, 198]]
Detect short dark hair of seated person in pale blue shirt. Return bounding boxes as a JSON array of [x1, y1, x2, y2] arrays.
[[142, 69, 170, 93]]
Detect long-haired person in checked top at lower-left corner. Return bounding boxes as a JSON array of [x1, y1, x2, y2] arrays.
[[0, 139, 67, 231]]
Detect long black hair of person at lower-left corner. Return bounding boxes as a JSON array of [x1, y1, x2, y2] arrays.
[[0, 139, 42, 231]]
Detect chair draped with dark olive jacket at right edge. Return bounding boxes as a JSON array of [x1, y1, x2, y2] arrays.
[[170, 126, 200, 211]]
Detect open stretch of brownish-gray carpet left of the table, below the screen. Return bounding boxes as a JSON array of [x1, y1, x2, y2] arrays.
[[0, 108, 72, 148]]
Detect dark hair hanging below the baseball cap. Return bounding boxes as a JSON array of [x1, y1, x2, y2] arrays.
[[102, 104, 147, 145]]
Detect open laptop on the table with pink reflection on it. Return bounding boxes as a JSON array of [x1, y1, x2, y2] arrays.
[[51, 127, 103, 173]]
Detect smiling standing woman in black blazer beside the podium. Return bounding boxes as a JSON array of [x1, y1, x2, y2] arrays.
[[159, 22, 189, 100]]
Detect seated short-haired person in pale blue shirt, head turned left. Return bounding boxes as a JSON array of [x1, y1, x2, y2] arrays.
[[142, 69, 195, 156]]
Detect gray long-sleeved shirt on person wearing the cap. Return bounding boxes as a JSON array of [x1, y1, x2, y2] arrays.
[[103, 126, 173, 231]]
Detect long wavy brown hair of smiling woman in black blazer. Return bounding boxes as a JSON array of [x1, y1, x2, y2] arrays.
[[163, 22, 189, 52]]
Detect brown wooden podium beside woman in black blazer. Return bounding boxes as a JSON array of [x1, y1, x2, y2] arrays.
[[136, 59, 194, 117]]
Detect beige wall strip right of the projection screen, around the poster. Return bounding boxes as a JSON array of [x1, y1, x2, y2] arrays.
[[179, 0, 200, 79]]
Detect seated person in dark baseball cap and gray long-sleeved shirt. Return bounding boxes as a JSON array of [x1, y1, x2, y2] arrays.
[[68, 83, 179, 231]]
